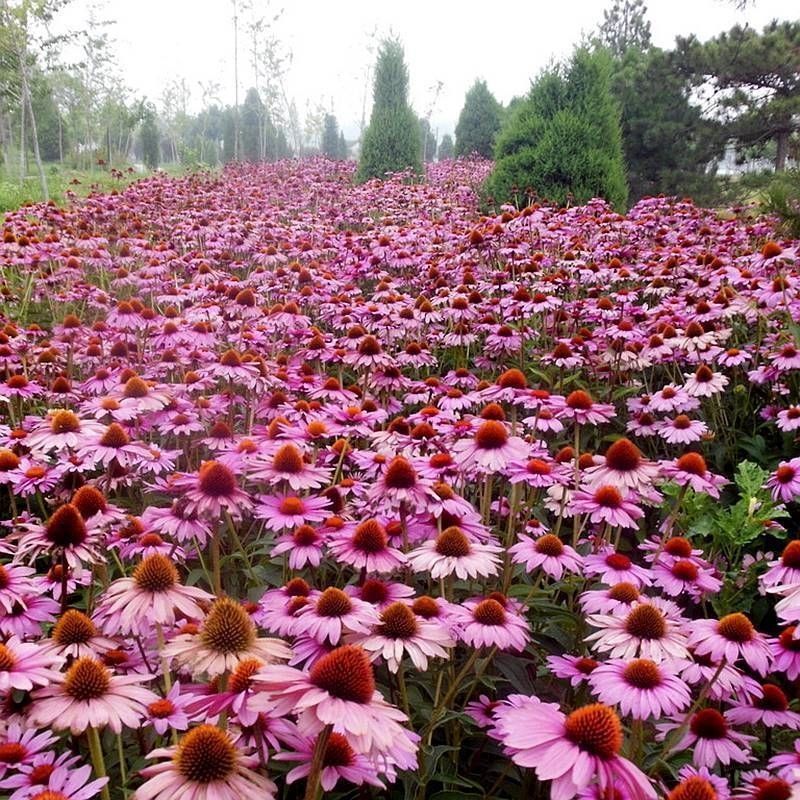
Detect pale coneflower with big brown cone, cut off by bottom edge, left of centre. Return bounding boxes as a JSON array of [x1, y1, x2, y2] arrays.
[[133, 725, 278, 800]]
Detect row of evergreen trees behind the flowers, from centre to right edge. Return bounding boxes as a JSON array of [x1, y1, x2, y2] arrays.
[[358, 0, 800, 207]]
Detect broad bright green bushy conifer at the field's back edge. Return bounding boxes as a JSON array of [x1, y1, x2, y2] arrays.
[[485, 49, 627, 208]]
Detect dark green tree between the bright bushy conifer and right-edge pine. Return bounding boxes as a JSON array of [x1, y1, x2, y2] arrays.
[[611, 48, 724, 200]]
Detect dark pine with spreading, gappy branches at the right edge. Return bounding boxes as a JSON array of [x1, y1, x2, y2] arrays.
[[677, 21, 800, 170]]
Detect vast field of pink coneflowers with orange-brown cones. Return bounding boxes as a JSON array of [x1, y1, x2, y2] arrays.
[[0, 159, 800, 800]]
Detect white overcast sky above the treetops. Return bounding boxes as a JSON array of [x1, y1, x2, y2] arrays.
[[62, 0, 800, 136]]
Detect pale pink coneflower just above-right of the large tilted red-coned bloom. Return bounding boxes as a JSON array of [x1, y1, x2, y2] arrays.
[[351, 601, 455, 672]]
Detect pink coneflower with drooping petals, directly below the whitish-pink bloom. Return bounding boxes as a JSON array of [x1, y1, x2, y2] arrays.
[[448, 592, 530, 652]]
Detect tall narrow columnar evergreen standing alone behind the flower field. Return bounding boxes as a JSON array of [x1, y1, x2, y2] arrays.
[[356, 39, 422, 182]]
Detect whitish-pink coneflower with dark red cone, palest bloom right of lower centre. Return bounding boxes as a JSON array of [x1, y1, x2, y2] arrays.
[[408, 525, 501, 580]]
